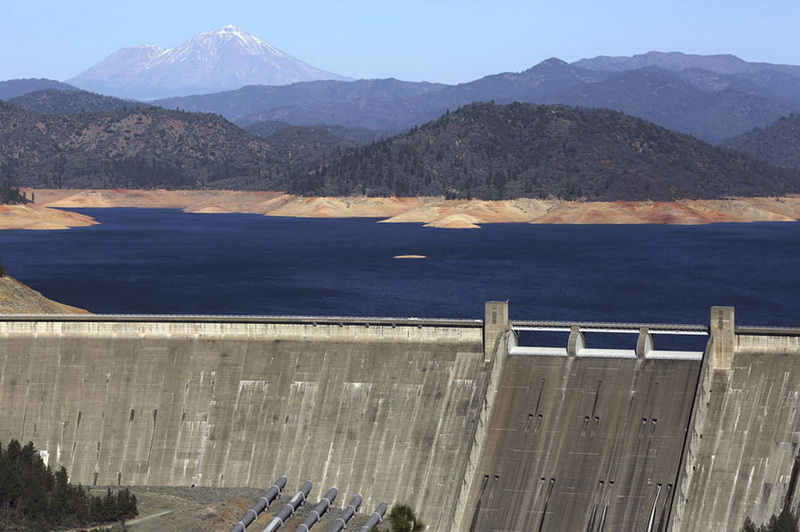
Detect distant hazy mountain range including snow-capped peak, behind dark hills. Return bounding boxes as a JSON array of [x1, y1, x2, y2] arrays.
[[0, 45, 800, 144]]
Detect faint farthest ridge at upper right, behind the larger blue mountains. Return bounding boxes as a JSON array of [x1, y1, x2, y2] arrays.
[[572, 52, 800, 77]]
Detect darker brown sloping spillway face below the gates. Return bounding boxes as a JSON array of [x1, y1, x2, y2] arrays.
[[462, 356, 700, 531]]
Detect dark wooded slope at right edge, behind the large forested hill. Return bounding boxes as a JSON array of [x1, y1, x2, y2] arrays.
[[723, 114, 800, 170]]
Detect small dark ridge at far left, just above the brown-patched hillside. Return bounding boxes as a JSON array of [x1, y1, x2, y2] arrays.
[[8, 89, 149, 114]]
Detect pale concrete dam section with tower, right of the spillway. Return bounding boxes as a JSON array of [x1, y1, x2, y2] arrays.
[[672, 307, 800, 532]]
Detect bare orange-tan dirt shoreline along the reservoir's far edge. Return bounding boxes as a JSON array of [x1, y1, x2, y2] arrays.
[[0, 189, 800, 229]]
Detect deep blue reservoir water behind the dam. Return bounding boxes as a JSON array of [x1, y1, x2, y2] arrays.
[[0, 209, 800, 326]]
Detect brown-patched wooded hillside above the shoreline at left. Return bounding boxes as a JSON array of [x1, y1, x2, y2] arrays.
[[0, 103, 282, 188]]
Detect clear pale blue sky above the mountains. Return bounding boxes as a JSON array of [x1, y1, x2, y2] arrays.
[[0, 0, 800, 83]]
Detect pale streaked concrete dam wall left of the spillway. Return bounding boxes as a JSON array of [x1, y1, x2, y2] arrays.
[[0, 317, 489, 530]]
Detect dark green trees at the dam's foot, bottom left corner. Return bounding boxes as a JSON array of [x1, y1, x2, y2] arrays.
[[0, 440, 138, 531]]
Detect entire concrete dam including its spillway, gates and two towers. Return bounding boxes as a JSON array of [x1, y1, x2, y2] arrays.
[[0, 302, 800, 532]]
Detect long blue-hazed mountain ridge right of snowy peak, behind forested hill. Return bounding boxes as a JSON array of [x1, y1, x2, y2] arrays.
[[154, 54, 800, 143]]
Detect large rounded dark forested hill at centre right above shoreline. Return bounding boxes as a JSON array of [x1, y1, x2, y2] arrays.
[[289, 103, 800, 201]]
